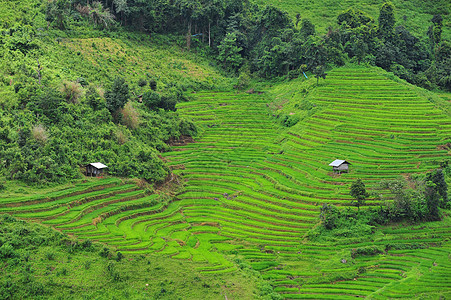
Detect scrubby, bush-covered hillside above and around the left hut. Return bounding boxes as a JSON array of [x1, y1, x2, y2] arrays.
[[0, 0, 230, 185]]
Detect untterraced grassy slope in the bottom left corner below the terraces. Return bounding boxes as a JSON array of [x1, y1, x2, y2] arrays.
[[0, 214, 255, 299]]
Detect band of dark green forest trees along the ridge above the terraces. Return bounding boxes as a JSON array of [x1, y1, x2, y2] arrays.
[[43, 0, 451, 90]]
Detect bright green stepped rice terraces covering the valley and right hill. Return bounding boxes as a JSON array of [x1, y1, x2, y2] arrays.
[[0, 67, 451, 299]]
